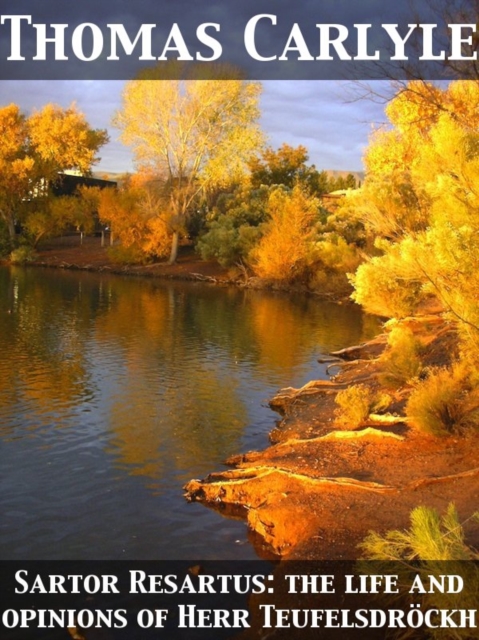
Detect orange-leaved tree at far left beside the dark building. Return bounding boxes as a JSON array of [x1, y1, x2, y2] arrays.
[[0, 104, 108, 246]]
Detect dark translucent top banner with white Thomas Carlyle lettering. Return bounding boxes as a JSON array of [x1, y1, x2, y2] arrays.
[[0, 0, 477, 80]]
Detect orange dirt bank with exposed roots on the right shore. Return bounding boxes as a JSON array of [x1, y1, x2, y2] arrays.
[[185, 316, 479, 559]]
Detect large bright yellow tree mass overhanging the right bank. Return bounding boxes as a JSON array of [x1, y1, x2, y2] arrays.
[[354, 81, 479, 356]]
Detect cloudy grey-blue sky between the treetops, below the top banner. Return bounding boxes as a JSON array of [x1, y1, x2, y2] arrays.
[[0, 80, 390, 172]]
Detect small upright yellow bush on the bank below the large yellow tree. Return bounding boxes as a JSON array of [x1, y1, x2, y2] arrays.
[[381, 325, 423, 386]]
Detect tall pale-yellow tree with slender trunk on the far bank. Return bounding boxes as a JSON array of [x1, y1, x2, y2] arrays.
[[114, 71, 262, 263]]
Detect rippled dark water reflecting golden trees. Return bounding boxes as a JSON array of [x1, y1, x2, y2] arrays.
[[0, 268, 377, 560]]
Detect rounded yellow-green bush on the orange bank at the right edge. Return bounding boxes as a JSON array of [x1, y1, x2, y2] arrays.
[[406, 363, 479, 436]]
